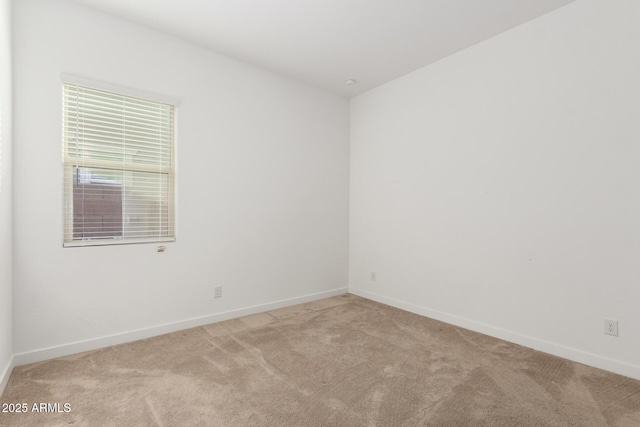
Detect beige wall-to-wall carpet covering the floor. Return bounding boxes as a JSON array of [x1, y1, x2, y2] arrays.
[[0, 295, 640, 427]]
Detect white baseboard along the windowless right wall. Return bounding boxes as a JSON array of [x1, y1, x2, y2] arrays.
[[349, 288, 640, 380]]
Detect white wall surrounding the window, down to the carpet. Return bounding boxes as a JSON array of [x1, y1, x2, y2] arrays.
[[14, 0, 349, 363]]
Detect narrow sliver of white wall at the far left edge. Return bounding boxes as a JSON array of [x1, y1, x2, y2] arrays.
[[0, 0, 13, 394]]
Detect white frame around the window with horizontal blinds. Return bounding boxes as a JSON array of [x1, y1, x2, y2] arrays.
[[61, 73, 179, 247]]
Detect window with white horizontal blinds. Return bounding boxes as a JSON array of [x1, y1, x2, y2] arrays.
[[63, 83, 175, 246]]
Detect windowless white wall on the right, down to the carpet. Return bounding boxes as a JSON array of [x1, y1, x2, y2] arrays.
[[350, 0, 640, 378]]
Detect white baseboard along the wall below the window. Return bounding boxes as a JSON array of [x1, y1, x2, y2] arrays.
[[13, 288, 348, 366]]
